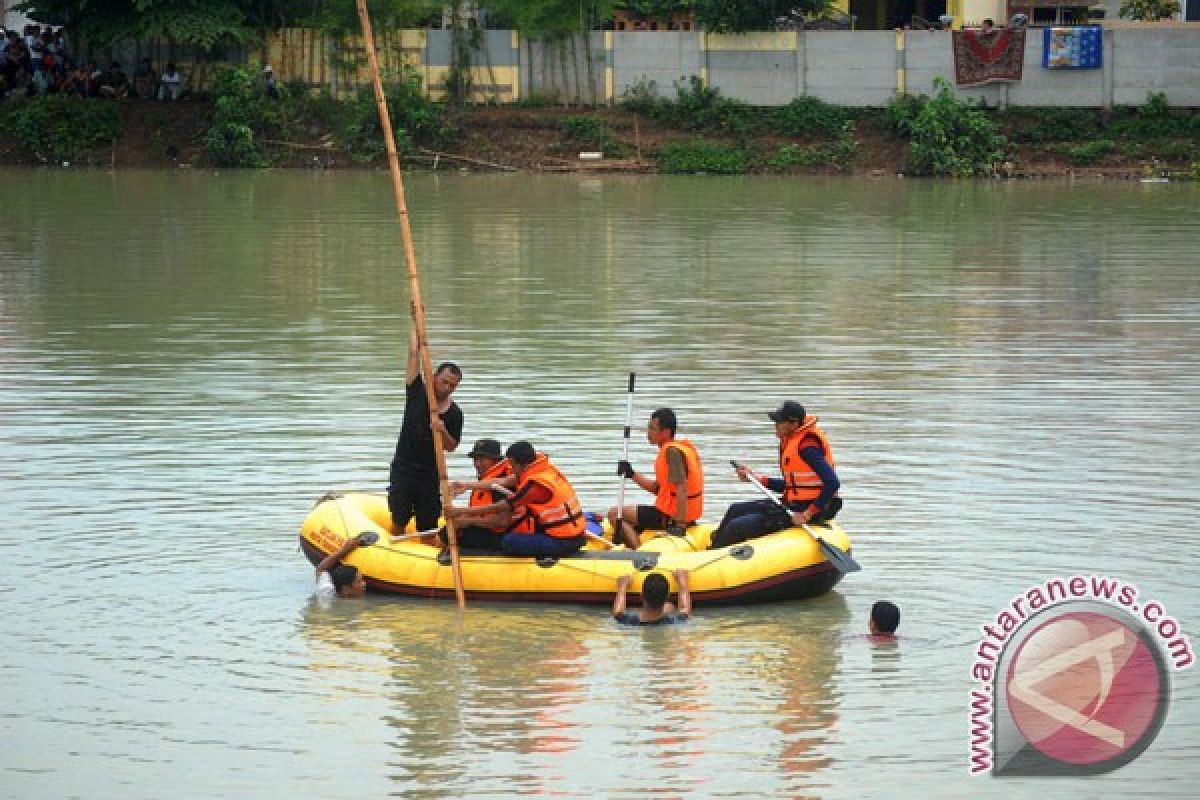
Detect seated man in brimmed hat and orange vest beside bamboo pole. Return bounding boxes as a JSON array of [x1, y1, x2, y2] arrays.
[[438, 439, 516, 564]]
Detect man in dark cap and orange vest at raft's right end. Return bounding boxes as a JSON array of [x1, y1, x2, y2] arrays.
[[712, 401, 841, 548]]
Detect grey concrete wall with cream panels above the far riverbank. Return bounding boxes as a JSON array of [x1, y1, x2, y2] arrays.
[[251, 25, 1200, 108]]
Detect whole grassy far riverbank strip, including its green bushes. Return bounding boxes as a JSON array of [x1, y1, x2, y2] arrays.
[[0, 70, 1200, 179]]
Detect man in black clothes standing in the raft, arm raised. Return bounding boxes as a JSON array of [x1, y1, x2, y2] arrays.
[[388, 330, 462, 534]]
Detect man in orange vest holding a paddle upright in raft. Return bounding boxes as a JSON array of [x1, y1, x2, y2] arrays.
[[608, 408, 704, 548]]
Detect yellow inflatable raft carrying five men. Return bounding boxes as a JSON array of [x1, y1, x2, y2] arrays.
[[300, 492, 850, 606]]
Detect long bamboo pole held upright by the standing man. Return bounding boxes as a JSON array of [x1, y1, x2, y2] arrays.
[[358, 0, 467, 608]]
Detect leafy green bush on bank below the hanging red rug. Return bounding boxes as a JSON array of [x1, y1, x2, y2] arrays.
[[907, 77, 1004, 178]]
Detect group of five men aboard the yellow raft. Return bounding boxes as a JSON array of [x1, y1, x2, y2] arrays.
[[388, 333, 841, 557]]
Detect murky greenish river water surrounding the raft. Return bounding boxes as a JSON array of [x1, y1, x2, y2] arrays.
[[0, 170, 1200, 799]]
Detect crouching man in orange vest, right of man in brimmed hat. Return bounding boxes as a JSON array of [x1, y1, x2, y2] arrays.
[[454, 441, 588, 557]]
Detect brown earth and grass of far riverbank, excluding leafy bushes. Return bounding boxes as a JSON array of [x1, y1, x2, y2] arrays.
[[0, 98, 1200, 179]]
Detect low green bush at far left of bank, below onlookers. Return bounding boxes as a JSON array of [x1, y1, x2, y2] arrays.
[[0, 95, 121, 163]]
